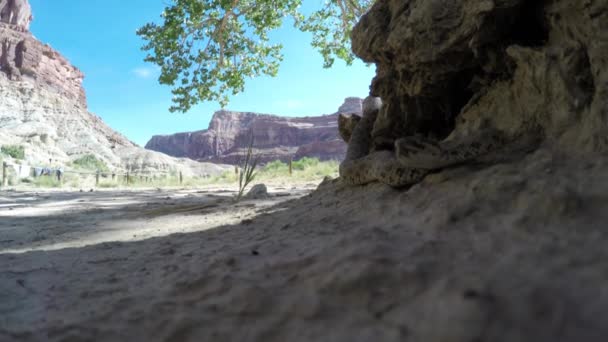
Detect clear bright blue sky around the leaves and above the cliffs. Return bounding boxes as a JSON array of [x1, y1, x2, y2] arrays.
[[30, 0, 374, 146]]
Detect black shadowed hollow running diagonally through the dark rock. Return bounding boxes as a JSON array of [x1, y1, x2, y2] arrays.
[[388, 0, 549, 148]]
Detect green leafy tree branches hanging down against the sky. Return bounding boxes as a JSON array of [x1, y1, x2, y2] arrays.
[[137, 0, 373, 112]]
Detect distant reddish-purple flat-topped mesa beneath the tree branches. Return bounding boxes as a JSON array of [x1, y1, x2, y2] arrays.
[[146, 97, 362, 163]]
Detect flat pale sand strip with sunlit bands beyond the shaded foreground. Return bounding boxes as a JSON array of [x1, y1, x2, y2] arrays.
[[0, 183, 317, 253]]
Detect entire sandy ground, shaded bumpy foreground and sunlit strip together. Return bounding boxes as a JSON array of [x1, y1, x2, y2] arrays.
[[0, 151, 608, 342]]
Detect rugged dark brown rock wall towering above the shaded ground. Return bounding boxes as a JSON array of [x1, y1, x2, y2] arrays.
[[353, 0, 608, 150]]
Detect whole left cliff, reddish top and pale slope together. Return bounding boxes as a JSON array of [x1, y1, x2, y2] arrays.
[[0, 0, 228, 174]]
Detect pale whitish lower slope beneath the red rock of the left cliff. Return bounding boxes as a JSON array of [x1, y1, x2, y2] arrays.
[[0, 62, 226, 177]]
